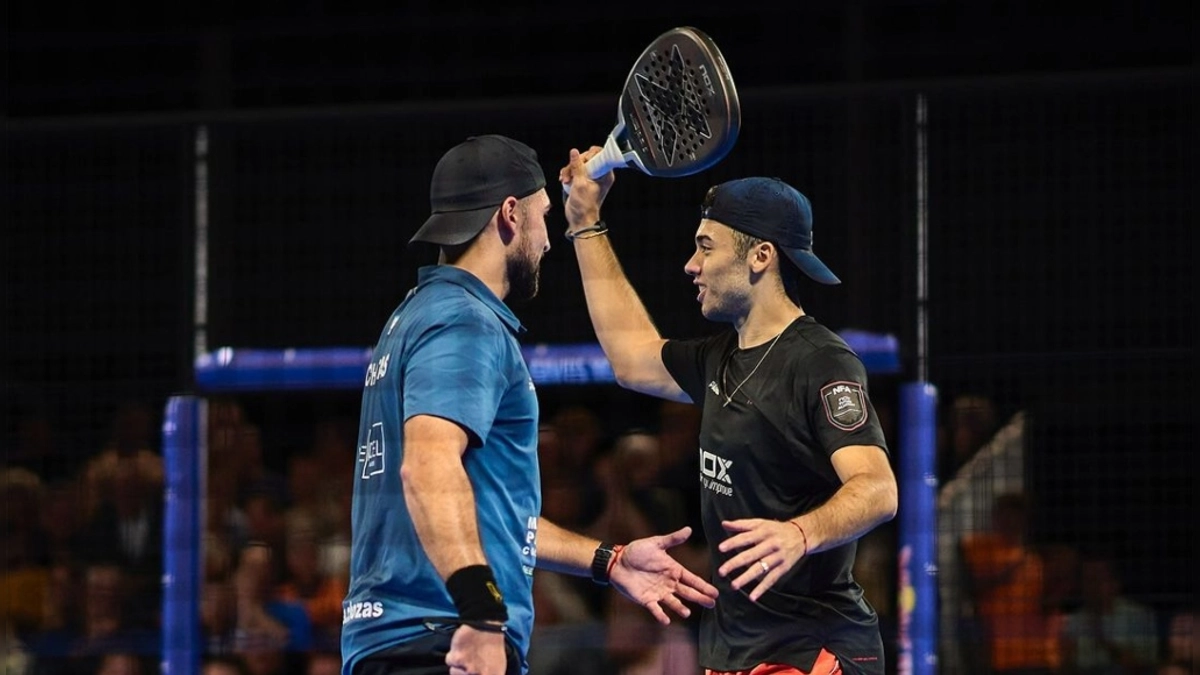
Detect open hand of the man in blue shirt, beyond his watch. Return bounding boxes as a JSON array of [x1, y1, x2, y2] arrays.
[[610, 527, 718, 626]]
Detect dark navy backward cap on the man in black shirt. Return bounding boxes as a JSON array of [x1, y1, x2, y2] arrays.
[[701, 177, 841, 285]]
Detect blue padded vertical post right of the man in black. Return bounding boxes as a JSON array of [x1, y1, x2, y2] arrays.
[[896, 382, 937, 675]]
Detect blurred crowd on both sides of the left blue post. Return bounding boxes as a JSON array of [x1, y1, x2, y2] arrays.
[[0, 400, 356, 675]]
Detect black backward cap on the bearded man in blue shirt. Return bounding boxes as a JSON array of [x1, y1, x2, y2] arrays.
[[408, 133, 546, 245]]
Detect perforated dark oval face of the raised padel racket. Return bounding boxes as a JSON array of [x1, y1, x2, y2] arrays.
[[619, 28, 740, 177]]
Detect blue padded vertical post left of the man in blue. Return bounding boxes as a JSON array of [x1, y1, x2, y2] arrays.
[[162, 396, 204, 675]]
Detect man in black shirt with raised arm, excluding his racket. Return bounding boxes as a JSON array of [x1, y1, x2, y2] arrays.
[[559, 148, 896, 675]]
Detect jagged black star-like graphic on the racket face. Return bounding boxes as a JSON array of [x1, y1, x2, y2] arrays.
[[634, 44, 713, 166]]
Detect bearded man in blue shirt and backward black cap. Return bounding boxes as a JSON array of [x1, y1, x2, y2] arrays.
[[342, 136, 716, 675]]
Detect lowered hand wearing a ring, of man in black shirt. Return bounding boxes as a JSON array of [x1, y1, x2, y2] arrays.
[[716, 518, 809, 602]]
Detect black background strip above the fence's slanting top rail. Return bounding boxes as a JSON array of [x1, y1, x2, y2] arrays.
[[4, 0, 1196, 118]]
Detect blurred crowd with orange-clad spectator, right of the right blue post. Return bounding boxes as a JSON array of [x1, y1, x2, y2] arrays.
[[937, 393, 1200, 675]]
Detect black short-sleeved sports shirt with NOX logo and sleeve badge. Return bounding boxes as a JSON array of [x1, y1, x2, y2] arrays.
[[662, 316, 887, 674]]
